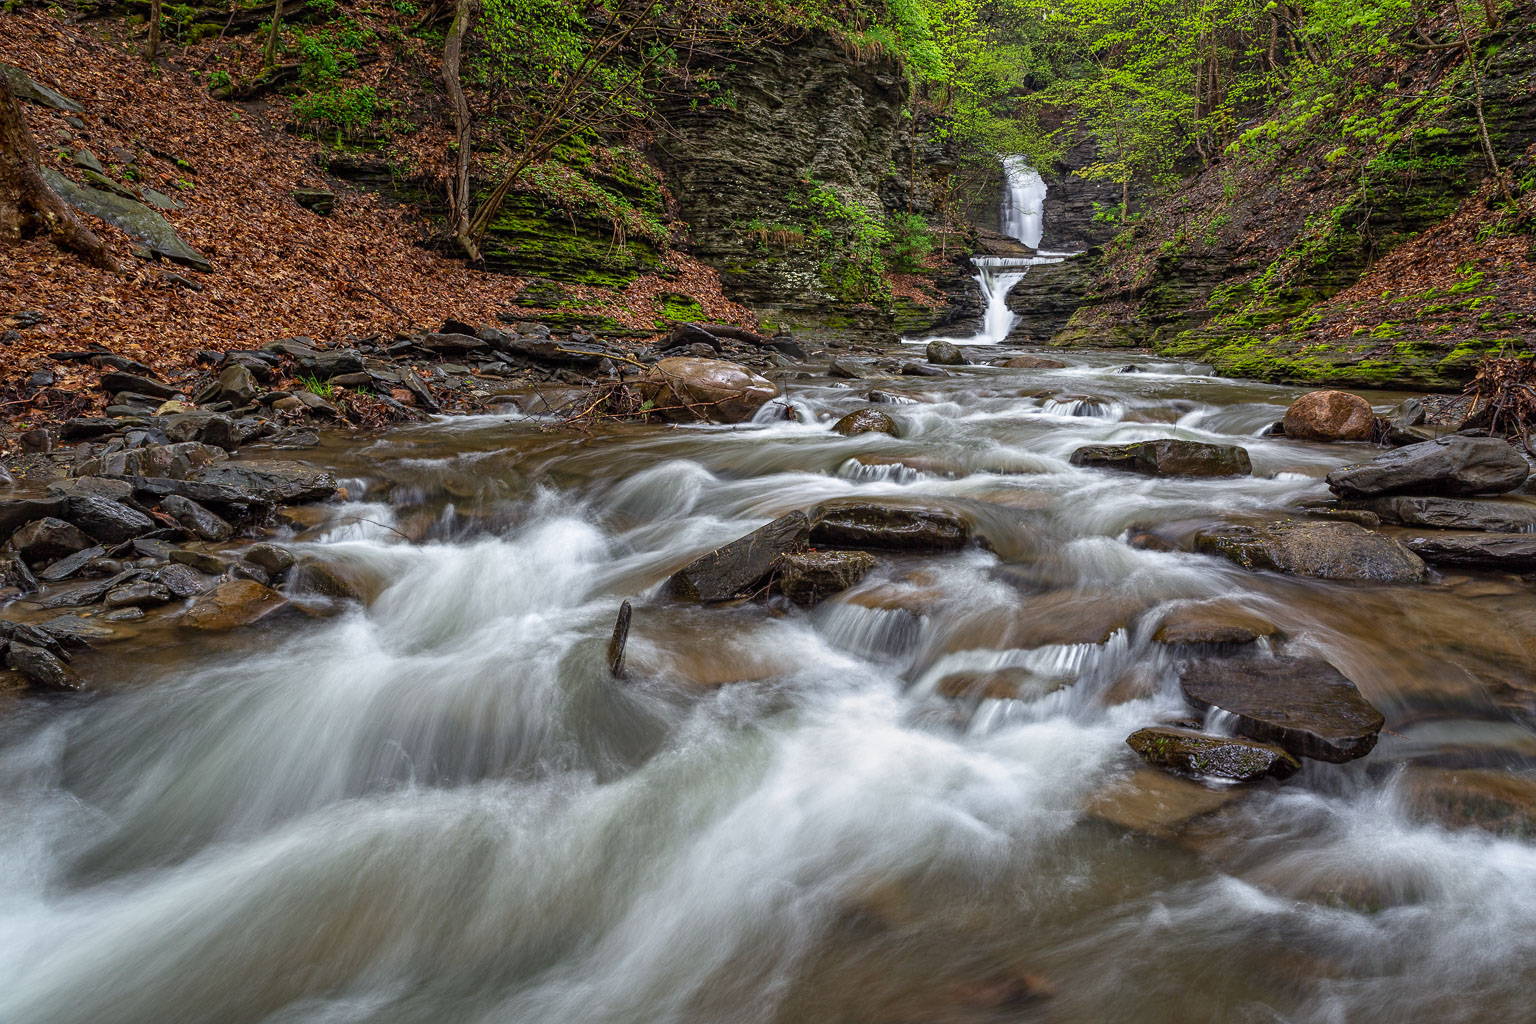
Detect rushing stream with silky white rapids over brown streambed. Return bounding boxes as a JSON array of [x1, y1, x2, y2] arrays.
[[0, 355, 1536, 1024]]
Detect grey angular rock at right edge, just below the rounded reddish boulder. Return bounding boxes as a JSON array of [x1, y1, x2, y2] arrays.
[[1329, 436, 1530, 497]]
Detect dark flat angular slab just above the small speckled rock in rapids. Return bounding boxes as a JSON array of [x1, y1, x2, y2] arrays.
[[1178, 657, 1385, 763]]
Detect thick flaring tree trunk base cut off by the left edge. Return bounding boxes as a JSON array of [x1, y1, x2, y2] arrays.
[[0, 77, 118, 272]]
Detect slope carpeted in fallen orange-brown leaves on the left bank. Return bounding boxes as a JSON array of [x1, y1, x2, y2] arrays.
[[0, 12, 746, 379]]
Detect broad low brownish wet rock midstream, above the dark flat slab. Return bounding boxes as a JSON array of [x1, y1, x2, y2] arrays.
[[1195, 519, 1425, 583]]
